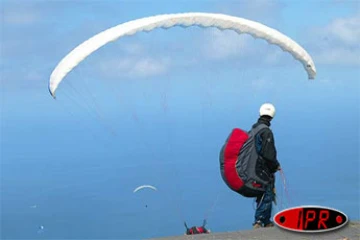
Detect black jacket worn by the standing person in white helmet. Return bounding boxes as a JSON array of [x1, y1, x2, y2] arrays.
[[252, 116, 280, 173]]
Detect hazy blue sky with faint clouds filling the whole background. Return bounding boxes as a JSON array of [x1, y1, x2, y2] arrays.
[[0, 0, 360, 239]]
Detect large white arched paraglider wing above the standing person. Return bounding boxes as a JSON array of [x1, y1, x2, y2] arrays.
[[49, 13, 316, 98]]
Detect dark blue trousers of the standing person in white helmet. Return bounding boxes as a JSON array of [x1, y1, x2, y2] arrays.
[[255, 184, 275, 226]]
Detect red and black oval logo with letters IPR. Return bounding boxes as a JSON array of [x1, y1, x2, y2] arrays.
[[274, 206, 348, 233]]
